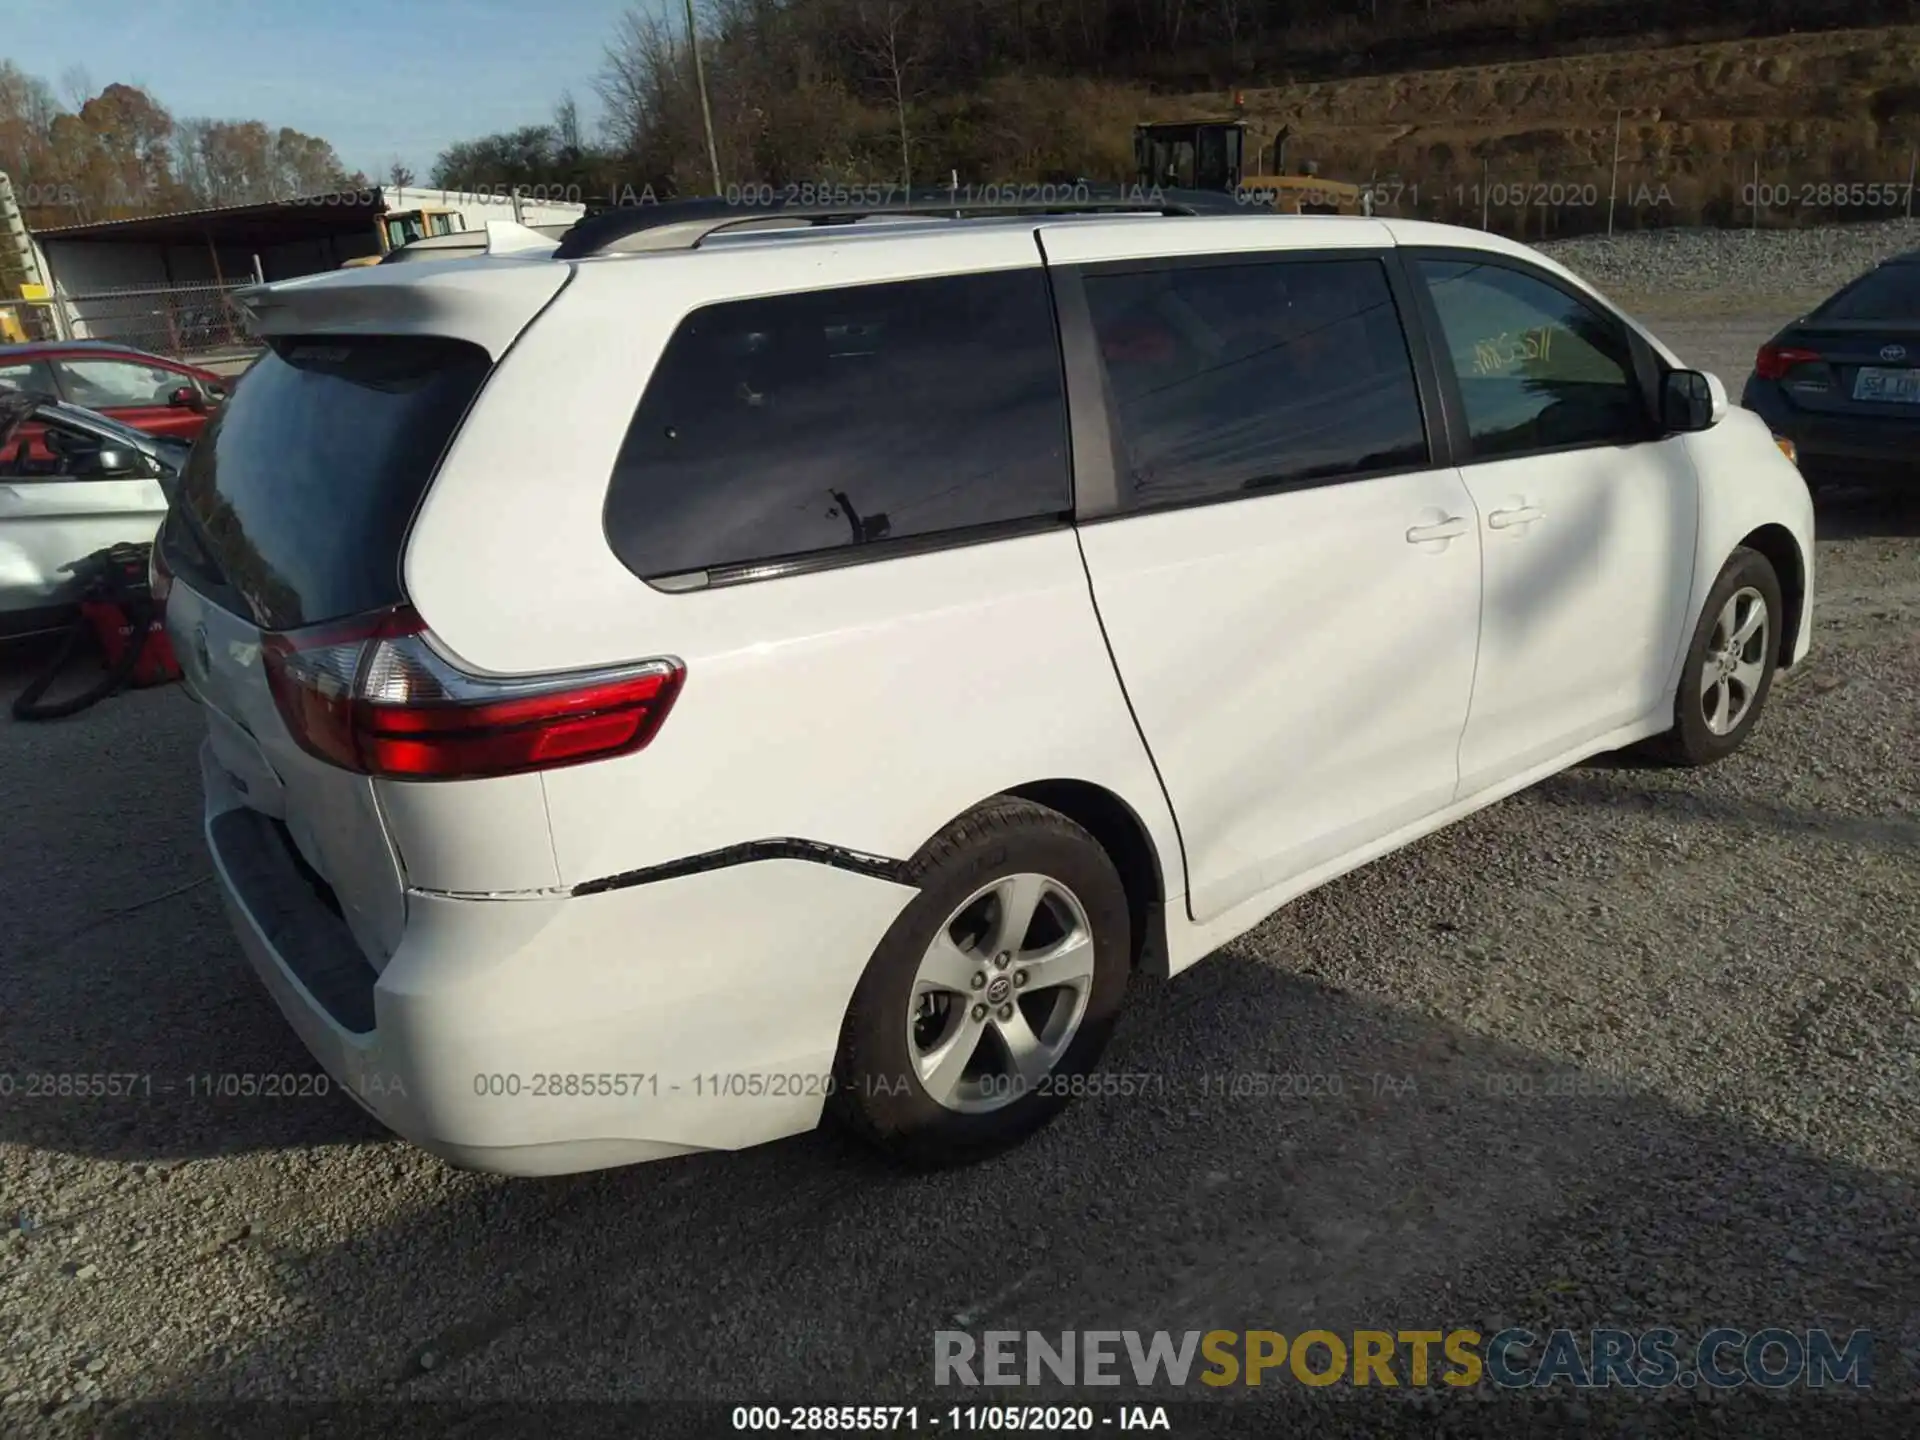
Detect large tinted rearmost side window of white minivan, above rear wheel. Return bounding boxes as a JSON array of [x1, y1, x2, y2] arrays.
[[606, 269, 1073, 580]]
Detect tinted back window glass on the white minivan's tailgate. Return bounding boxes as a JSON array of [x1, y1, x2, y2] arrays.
[[179, 336, 492, 630]]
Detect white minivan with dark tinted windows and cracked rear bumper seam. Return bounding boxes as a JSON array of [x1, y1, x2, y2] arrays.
[[156, 202, 1812, 1175]]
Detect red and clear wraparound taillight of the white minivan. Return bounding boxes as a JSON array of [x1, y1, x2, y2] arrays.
[[263, 607, 685, 780]]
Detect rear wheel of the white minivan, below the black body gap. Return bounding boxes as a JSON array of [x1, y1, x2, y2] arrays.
[[831, 797, 1131, 1165]]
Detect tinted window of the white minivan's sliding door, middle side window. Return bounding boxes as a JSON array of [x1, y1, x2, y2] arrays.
[[1087, 259, 1427, 507]]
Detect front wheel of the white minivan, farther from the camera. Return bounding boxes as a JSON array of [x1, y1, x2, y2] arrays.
[[1653, 547, 1786, 766]]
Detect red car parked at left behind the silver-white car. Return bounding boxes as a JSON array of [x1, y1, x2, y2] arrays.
[[0, 340, 232, 442]]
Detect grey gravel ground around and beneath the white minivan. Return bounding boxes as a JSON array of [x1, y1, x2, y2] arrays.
[[0, 238, 1920, 1436]]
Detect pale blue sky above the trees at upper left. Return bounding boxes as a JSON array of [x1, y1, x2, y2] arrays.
[[0, 0, 662, 180]]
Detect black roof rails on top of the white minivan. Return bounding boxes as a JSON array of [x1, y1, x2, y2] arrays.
[[553, 184, 1246, 259]]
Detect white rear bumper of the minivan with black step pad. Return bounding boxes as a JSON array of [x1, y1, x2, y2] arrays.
[[202, 749, 914, 1175]]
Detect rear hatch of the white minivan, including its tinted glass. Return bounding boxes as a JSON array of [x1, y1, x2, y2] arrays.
[[161, 334, 493, 968]]
